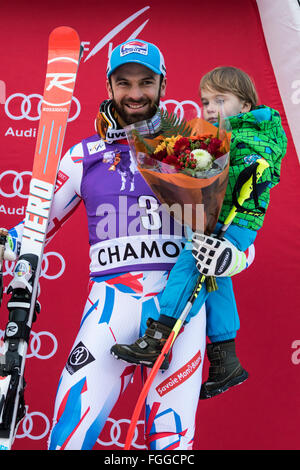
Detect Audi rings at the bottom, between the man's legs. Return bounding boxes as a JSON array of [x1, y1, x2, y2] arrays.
[[97, 418, 147, 450]]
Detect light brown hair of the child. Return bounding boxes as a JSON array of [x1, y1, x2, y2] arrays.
[[200, 67, 258, 109]]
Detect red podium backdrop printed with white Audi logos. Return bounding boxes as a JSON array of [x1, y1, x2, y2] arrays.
[[0, 0, 300, 450]]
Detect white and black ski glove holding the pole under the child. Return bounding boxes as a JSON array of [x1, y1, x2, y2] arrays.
[[192, 233, 248, 277]]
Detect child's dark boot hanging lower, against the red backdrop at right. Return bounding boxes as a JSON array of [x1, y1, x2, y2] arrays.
[[200, 340, 248, 400]]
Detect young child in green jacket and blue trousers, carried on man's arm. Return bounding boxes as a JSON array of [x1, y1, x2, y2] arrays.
[[111, 67, 287, 398]]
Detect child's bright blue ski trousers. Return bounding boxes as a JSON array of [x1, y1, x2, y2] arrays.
[[160, 223, 257, 342]]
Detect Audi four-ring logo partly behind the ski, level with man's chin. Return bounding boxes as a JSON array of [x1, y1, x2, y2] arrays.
[[4, 93, 81, 122]]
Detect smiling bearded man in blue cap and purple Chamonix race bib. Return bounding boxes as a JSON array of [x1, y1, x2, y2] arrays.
[[7, 39, 205, 450]]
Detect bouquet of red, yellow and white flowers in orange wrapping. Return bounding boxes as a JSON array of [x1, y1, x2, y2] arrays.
[[125, 110, 231, 235]]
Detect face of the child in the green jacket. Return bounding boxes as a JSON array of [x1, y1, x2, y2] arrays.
[[200, 88, 251, 123]]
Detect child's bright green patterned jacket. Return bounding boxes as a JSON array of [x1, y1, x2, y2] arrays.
[[219, 105, 287, 230]]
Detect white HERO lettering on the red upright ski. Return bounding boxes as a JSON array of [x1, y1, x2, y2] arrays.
[[23, 178, 53, 243]]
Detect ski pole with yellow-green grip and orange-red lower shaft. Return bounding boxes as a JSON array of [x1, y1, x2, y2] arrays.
[[124, 158, 269, 450]]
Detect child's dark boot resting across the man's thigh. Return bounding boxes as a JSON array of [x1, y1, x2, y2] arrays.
[[110, 318, 172, 370]]
